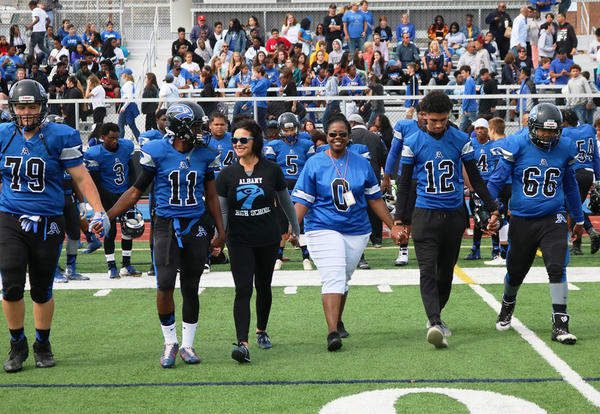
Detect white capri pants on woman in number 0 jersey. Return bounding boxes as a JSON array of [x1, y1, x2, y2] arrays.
[[306, 230, 371, 295]]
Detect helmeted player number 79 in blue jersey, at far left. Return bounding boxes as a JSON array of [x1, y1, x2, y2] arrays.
[[0, 79, 110, 372]]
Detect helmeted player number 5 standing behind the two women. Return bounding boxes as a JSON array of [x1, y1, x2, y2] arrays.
[[264, 112, 315, 270]]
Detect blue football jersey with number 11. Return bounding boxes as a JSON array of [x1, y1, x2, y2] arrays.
[[140, 139, 221, 218]]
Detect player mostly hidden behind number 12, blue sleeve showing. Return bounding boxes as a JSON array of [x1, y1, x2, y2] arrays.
[[381, 104, 427, 266]]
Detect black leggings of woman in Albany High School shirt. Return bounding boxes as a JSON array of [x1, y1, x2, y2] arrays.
[[227, 242, 279, 342]]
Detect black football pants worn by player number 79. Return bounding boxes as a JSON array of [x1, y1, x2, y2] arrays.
[[0, 212, 65, 303]]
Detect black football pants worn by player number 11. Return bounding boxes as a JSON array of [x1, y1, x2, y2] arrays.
[[154, 214, 211, 290]]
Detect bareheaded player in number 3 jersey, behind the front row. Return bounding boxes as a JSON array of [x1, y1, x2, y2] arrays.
[[83, 122, 142, 279]]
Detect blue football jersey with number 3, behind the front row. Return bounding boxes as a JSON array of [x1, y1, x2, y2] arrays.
[[83, 138, 135, 194]]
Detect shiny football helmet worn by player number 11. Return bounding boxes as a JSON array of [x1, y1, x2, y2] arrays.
[[166, 101, 210, 147]]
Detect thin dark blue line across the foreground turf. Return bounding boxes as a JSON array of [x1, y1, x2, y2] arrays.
[[0, 377, 600, 388]]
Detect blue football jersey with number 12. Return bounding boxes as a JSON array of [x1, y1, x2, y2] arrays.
[[401, 128, 473, 210]]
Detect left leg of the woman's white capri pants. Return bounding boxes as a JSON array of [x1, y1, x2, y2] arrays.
[[306, 230, 346, 294]]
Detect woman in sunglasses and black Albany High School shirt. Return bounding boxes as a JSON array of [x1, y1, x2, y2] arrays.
[[217, 120, 300, 362]]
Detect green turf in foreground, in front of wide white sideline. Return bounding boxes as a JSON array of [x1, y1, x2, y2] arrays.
[[0, 284, 600, 413]]
